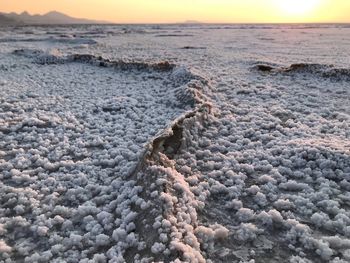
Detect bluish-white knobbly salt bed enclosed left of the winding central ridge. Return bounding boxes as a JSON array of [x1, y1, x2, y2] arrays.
[[0, 50, 208, 262]]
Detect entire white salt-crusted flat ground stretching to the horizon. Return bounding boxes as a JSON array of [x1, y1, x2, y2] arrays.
[[0, 25, 350, 263]]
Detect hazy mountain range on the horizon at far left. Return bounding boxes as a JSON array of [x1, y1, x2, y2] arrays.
[[0, 11, 107, 25]]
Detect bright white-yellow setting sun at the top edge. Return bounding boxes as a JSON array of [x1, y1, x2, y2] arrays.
[[276, 0, 321, 16]]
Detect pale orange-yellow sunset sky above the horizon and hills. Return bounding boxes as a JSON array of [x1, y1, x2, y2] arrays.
[[0, 0, 350, 23]]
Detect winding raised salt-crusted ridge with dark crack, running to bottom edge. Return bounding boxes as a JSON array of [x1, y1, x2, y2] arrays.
[[121, 65, 221, 263]]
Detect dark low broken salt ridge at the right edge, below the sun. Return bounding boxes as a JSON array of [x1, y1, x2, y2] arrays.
[[252, 63, 350, 81]]
